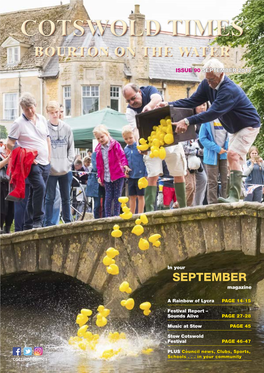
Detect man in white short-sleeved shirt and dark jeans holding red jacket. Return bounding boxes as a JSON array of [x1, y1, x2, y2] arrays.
[[7, 93, 51, 230]]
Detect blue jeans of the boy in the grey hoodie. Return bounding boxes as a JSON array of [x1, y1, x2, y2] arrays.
[[44, 171, 72, 227]]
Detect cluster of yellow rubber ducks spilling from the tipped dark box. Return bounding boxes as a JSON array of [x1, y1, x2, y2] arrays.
[[137, 117, 174, 159]]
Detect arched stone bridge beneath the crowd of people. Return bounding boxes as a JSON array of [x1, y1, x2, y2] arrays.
[[1, 202, 264, 314]]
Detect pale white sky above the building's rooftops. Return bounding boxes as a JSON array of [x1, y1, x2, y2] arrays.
[[0, 0, 246, 31]]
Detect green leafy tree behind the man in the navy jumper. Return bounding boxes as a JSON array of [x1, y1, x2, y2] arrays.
[[214, 0, 264, 156]]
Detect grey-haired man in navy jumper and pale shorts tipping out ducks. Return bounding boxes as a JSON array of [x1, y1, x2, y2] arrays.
[[159, 58, 260, 203]]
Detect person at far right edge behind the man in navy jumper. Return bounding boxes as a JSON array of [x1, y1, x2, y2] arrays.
[[244, 146, 264, 203]]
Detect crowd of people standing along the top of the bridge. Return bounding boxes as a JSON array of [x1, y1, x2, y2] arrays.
[[0, 59, 264, 233]]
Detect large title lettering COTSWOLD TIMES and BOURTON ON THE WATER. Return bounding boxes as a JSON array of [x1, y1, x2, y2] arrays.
[[21, 20, 243, 57]]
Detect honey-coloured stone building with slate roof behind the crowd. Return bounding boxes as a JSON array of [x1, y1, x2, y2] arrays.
[[0, 0, 245, 131]]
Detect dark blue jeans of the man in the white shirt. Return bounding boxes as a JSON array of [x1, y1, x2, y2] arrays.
[[24, 164, 50, 230]]
